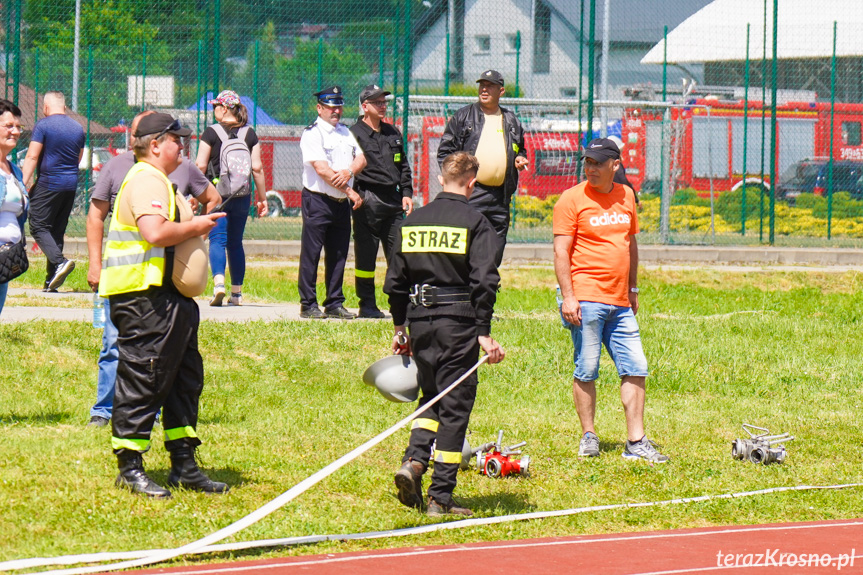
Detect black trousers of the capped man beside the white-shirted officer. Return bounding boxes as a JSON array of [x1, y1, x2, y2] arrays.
[[352, 182, 404, 311]]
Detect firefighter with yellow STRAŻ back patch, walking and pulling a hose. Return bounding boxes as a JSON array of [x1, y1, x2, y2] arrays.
[[384, 152, 504, 516]]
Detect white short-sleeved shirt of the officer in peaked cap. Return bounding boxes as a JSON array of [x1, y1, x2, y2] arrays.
[[300, 117, 363, 200]]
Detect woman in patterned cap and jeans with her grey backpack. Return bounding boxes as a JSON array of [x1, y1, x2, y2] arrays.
[[195, 90, 267, 306]]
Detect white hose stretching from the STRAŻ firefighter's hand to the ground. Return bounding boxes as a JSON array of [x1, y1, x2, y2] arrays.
[[30, 355, 488, 575]]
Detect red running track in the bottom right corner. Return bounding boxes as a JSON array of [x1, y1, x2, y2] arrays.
[[130, 519, 863, 575]]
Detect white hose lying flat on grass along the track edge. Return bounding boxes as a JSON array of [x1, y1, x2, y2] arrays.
[[8, 483, 863, 571]]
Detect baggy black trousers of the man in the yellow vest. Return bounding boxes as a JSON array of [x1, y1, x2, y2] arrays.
[[110, 287, 204, 453]]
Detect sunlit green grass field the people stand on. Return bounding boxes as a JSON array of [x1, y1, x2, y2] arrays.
[[0, 263, 863, 563]]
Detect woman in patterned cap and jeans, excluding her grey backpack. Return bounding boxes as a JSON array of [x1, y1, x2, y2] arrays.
[[195, 90, 267, 306]]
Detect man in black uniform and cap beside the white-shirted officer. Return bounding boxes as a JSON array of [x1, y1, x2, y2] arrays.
[[351, 84, 414, 319]]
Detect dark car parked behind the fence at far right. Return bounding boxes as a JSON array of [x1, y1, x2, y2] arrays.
[[776, 158, 863, 204]]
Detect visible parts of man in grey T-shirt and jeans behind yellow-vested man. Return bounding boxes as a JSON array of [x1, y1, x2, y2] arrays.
[[87, 110, 221, 427]]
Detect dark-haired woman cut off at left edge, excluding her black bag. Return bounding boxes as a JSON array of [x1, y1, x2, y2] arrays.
[[0, 99, 29, 311]]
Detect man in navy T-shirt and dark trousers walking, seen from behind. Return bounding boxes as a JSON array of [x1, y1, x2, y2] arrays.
[[24, 92, 84, 291]]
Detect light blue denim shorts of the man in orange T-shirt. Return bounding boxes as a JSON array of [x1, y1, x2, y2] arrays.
[[561, 301, 648, 381]]
